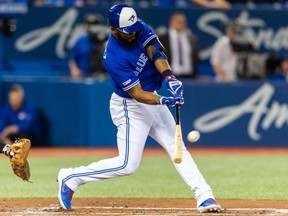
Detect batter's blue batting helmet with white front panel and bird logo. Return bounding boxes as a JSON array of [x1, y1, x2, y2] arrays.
[[107, 4, 142, 34]]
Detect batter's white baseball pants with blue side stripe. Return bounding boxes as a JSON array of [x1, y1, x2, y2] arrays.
[[66, 93, 214, 206]]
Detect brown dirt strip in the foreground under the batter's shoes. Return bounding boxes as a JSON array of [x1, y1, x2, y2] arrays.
[[0, 198, 288, 216]]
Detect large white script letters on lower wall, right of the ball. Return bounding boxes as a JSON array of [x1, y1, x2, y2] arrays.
[[194, 83, 288, 140]]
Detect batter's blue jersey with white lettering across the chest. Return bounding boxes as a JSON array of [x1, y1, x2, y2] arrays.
[[103, 20, 162, 98]]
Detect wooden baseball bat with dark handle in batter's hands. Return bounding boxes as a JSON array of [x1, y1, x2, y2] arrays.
[[174, 104, 182, 163]]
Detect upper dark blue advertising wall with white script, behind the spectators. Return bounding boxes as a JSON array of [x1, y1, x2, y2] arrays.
[[4, 7, 288, 70]]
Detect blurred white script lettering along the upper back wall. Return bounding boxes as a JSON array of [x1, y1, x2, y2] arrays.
[[15, 8, 288, 59]]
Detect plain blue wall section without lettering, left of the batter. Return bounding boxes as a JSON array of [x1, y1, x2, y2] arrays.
[[2, 76, 116, 146]]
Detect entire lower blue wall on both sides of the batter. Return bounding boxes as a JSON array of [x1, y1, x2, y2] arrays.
[[3, 77, 288, 147]]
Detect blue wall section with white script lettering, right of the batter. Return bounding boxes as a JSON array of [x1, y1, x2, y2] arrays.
[[182, 82, 288, 147]]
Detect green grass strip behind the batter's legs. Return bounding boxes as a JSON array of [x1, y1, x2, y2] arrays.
[[0, 155, 288, 200]]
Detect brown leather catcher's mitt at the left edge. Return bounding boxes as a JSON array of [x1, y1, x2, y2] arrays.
[[7, 139, 31, 182]]
